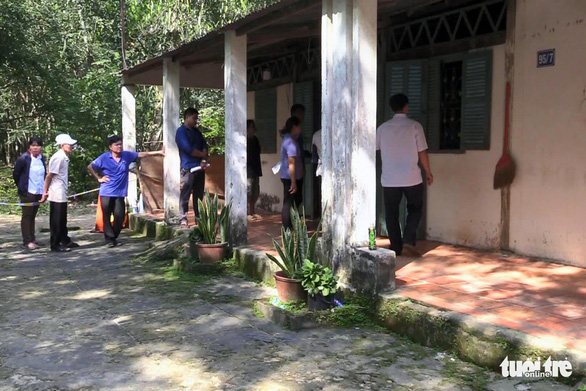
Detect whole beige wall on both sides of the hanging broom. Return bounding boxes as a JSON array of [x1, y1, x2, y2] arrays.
[[427, 0, 586, 266]]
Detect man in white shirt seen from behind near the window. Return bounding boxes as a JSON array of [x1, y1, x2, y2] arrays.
[[376, 94, 433, 257]]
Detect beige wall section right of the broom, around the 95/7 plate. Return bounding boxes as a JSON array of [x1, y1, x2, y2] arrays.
[[511, 0, 586, 266]]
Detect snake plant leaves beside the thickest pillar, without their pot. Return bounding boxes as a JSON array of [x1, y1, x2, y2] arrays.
[[266, 207, 321, 279]]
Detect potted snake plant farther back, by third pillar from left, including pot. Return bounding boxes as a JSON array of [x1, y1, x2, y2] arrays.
[[194, 190, 230, 263]]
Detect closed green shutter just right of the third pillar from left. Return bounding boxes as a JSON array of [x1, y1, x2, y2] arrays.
[[254, 88, 278, 153]]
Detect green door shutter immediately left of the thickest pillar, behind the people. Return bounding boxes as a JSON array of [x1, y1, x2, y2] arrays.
[[293, 81, 314, 217]]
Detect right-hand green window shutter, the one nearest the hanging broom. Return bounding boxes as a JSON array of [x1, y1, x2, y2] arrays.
[[462, 51, 492, 150]]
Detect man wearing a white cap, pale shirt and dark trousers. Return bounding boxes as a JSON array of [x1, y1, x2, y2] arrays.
[[41, 134, 79, 252]]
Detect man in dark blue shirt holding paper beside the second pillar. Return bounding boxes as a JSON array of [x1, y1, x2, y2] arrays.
[[175, 107, 209, 228]]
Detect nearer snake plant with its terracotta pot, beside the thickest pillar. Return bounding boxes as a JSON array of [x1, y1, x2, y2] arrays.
[[266, 207, 321, 302]]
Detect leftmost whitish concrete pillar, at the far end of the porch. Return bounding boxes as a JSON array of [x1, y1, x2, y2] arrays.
[[121, 85, 138, 212]]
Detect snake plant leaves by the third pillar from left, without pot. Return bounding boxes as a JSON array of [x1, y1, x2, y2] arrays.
[[197, 190, 230, 244]]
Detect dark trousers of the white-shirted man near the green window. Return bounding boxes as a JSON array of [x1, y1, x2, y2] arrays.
[[383, 183, 423, 255]]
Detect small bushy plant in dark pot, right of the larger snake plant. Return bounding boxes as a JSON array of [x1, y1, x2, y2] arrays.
[[301, 259, 338, 311]]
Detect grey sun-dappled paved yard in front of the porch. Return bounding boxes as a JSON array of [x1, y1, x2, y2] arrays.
[[0, 215, 574, 391]]
